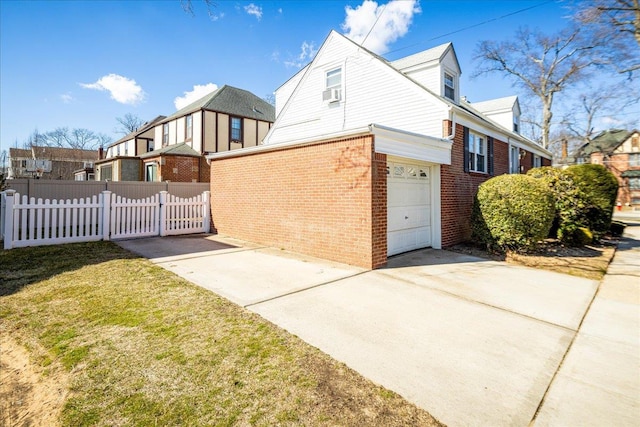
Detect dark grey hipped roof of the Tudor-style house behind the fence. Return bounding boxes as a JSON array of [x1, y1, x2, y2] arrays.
[[163, 85, 276, 122]]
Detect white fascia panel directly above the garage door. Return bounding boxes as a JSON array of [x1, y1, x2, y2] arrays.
[[369, 124, 453, 165]]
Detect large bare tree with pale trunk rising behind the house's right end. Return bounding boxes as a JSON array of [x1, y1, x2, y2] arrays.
[[474, 26, 601, 148]]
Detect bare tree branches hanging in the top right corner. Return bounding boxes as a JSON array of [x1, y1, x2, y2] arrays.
[[575, 0, 640, 78]]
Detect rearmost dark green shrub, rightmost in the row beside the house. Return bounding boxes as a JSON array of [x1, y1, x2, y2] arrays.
[[567, 164, 618, 239]]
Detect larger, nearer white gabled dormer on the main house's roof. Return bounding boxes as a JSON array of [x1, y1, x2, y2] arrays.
[[391, 43, 462, 104]]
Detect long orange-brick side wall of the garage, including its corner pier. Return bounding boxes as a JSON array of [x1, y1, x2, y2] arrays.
[[210, 135, 387, 268]]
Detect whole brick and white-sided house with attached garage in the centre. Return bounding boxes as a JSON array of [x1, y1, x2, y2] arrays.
[[207, 31, 551, 268]]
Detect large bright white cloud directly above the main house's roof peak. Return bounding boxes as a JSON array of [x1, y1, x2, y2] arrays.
[[342, 0, 421, 54]]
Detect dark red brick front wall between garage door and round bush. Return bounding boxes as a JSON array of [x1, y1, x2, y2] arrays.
[[440, 124, 509, 248]]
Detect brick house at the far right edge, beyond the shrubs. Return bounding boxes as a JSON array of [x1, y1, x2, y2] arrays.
[[572, 129, 640, 207]]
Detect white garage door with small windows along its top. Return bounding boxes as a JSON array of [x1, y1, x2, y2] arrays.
[[387, 162, 431, 256]]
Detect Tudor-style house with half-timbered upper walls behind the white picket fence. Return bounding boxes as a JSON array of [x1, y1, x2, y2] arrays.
[[96, 85, 275, 182]]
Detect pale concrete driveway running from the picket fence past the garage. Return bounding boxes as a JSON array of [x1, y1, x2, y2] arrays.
[[119, 235, 637, 426]]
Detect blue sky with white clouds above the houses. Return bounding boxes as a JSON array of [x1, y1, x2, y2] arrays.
[[0, 0, 640, 154]]
